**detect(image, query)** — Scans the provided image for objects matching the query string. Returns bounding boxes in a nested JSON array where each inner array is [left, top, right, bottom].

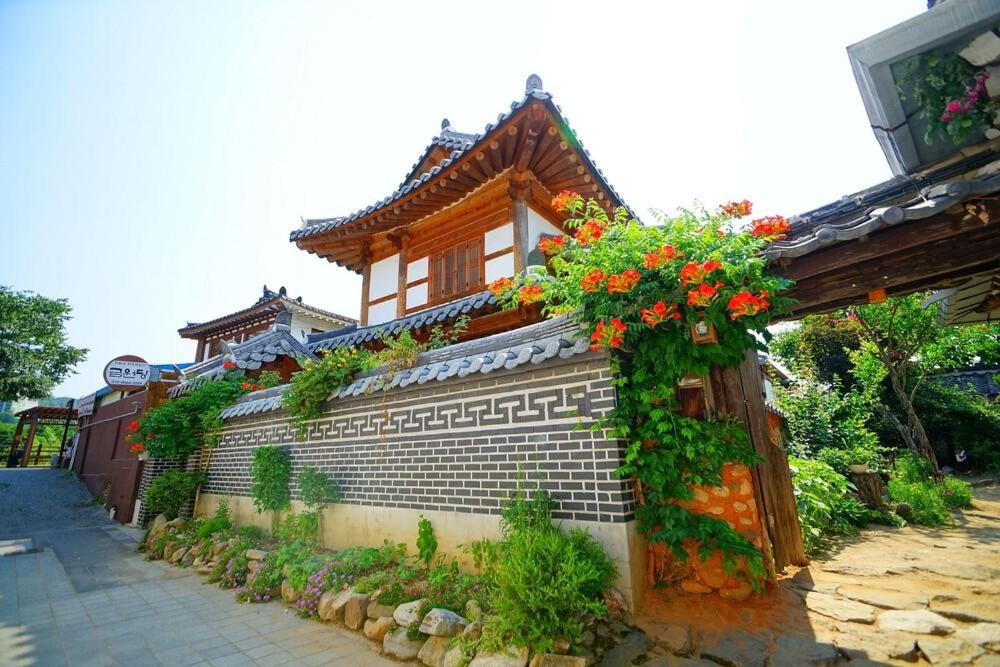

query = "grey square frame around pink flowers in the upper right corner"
[[847, 0, 1000, 175]]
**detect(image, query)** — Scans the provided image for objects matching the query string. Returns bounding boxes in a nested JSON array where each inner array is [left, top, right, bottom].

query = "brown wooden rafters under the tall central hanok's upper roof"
[[293, 95, 622, 273]]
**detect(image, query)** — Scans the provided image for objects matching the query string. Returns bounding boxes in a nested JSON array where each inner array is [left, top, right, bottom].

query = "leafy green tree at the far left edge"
[[0, 285, 87, 401]]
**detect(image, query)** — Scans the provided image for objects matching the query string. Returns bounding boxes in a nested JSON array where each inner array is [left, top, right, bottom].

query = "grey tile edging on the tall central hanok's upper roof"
[[289, 75, 628, 241]]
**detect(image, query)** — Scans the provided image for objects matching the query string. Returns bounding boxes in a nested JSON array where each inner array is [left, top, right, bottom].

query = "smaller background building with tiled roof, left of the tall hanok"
[[177, 285, 357, 362]]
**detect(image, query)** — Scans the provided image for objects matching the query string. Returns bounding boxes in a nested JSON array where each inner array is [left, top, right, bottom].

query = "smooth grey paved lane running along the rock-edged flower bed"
[[0, 469, 393, 667]]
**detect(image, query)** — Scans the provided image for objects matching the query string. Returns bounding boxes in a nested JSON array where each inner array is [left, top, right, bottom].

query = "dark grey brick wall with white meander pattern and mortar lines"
[[204, 354, 635, 523]]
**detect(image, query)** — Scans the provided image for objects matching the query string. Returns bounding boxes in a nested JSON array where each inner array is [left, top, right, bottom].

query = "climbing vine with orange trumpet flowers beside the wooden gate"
[[490, 192, 790, 585]]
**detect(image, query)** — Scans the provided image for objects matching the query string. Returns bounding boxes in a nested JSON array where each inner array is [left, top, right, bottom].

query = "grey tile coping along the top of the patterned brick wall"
[[222, 316, 589, 419]]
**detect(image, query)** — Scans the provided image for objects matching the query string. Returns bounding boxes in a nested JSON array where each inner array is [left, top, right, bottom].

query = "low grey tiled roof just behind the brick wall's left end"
[[168, 324, 316, 398]]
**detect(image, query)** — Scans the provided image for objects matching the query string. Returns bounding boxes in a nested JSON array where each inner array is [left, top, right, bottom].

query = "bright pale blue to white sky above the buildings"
[[0, 0, 925, 396]]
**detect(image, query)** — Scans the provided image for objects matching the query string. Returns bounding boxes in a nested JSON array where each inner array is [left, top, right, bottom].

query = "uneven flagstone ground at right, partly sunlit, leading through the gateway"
[[636, 482, 1000, 666]]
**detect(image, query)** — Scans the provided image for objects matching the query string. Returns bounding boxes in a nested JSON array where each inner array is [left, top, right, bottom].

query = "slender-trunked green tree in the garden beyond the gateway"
[[848, 294, 1000, 472]]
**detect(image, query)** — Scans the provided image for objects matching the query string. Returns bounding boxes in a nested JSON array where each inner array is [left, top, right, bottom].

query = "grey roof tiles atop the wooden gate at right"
[[764, 150, 1000, 261]]
